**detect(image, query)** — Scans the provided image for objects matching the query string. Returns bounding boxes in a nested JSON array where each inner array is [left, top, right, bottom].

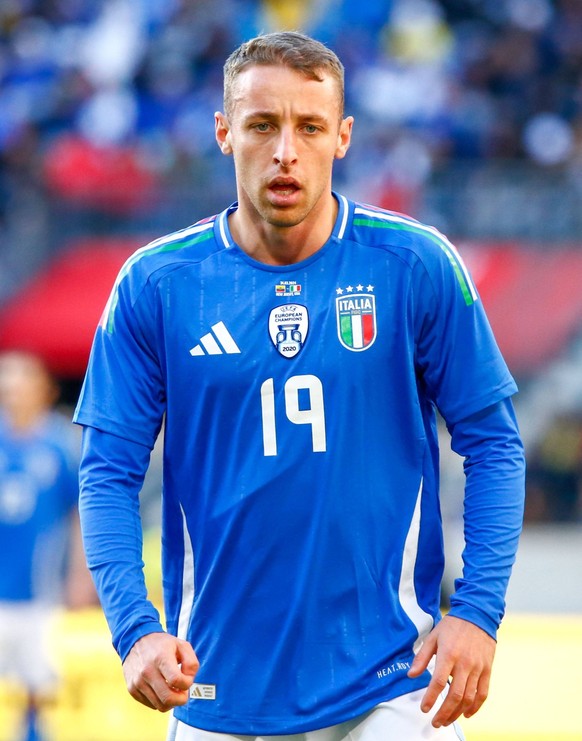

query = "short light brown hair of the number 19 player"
[[224, 31, 344, 118]]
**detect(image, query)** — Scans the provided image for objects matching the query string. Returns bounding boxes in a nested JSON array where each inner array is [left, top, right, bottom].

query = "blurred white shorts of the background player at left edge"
[[0, 602, 57, 694]]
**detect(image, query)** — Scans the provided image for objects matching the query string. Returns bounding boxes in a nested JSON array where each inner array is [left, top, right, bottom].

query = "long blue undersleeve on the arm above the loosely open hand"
[[449, 399, 525, 638]]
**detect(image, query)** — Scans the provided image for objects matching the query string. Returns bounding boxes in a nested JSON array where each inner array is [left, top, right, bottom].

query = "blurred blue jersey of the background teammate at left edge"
[[0, 413, 78, 602]]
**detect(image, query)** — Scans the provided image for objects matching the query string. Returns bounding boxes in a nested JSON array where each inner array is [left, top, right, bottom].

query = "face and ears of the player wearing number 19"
[[216, 65, 353, 227]]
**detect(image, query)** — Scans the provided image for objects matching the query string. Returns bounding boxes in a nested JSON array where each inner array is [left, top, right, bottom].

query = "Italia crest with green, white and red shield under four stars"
[[335, 286, 377, 352]]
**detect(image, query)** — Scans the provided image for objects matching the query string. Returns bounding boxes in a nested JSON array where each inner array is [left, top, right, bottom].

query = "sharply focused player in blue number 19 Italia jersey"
[[75, 32, 524, 741]]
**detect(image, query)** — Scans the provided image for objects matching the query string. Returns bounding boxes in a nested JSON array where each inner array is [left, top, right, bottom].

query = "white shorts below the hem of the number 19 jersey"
[[167, 689, 465, 741]]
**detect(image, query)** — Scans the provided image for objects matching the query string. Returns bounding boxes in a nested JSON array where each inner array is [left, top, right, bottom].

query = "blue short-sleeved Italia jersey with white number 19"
[[76, 195, 516, 734]]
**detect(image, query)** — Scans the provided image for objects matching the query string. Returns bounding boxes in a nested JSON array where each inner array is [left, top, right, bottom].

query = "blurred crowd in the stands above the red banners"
[[0, 0, 582, 284]]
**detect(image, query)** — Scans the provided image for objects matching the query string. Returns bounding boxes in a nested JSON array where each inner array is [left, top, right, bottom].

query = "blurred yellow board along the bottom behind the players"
[[0, 608, 582, 741]]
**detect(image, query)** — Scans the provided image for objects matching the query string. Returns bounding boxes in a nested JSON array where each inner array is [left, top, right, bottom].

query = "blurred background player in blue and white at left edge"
[[0, 351, 89, 741]]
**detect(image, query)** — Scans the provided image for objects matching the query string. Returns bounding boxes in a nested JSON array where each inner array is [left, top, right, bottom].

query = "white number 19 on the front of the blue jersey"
[[261, 375, 326, 456]]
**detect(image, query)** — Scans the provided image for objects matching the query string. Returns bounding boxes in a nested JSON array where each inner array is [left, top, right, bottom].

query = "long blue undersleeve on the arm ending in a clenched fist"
[[79, 427, 163, 661]]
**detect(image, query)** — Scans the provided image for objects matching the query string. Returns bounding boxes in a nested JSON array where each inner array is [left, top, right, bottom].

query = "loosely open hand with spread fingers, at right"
[[408, 615, 497, 728]]
